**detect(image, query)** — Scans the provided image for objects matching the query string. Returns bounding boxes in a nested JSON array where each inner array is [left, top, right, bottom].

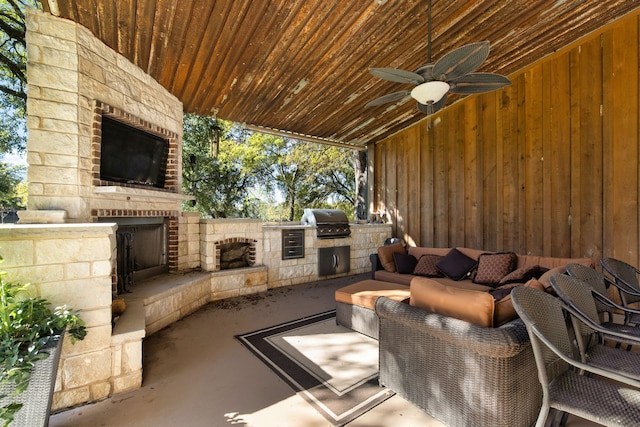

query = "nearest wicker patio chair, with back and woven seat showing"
[[511, 286, 640, 427]]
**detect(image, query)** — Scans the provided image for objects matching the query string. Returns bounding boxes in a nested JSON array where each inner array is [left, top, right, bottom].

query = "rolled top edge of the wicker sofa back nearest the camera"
[[376, 297, 530, 358]]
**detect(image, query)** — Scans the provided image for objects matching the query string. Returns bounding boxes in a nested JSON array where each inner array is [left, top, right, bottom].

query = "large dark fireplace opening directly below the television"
[[101, 217, 169, 294]]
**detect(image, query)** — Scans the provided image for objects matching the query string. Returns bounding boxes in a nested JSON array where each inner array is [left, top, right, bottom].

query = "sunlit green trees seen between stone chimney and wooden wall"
[[182, 114, 356, 221]]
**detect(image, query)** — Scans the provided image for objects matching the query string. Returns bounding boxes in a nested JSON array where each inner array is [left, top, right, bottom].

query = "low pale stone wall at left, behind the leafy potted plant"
[[0, 224, 144, 410]]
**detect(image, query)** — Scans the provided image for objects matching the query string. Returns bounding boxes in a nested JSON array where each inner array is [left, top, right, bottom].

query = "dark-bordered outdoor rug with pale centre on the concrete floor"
[[236, 310, 394, 426]]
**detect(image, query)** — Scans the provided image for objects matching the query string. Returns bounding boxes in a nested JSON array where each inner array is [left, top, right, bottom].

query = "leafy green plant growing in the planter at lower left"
[[0, 272, 86, 426]]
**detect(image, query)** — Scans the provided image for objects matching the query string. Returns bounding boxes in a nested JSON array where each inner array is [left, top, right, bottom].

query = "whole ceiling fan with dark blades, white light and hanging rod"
[[365, 0, 511, 114]]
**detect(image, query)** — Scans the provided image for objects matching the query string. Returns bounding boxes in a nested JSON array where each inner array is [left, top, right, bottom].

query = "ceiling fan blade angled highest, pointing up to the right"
[[433, 41, 489, 82]]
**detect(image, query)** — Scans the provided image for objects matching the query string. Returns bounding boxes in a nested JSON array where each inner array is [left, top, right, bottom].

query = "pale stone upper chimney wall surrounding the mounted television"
[[27, 9, 184, 222]]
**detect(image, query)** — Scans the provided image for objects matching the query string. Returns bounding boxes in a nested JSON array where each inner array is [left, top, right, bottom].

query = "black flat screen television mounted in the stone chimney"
[[100, 116, 169, 188]]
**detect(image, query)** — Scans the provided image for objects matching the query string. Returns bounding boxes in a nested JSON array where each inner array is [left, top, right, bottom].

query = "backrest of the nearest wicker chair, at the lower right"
[[511, 286, 574, 390]]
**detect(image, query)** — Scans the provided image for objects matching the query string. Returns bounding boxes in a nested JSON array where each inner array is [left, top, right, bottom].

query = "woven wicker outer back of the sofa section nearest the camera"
[[376, 297, 542, 427]]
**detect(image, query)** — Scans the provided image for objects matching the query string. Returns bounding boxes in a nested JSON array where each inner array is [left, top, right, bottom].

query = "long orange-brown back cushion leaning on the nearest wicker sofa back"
[[409, 277, 494, 327]]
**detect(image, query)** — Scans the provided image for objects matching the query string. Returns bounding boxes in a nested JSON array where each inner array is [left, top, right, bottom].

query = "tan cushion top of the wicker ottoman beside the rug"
[[335, 280, 409, 310]]
